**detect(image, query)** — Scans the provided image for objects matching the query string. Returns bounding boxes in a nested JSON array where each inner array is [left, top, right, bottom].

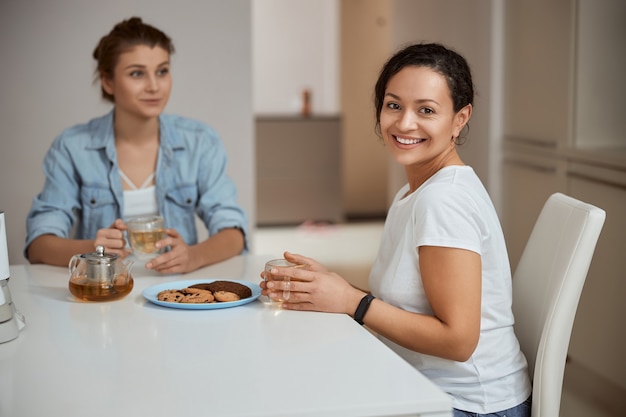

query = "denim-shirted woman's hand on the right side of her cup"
[[146, 229, 197, 274]]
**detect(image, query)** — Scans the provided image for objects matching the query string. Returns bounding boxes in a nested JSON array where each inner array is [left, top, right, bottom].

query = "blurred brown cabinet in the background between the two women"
[[255, 116, 343, 226]]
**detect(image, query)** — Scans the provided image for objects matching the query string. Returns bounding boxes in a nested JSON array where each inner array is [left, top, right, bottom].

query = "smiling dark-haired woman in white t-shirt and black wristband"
[[261, 44, 531, 417]]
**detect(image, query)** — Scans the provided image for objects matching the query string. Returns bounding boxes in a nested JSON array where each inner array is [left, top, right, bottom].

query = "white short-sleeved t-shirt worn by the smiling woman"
[[369, 166, 531, 414]]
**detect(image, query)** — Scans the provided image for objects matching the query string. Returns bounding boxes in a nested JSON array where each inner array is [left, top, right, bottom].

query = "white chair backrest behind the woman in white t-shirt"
[[513, 193, 606, 417]]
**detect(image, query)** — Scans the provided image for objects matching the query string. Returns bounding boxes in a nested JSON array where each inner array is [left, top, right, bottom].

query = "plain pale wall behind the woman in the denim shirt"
[[0, 0, 255, 264]]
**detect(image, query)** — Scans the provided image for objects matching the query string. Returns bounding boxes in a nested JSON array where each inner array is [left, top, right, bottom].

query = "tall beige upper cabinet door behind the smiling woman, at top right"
[[504, 0, 575, 147]]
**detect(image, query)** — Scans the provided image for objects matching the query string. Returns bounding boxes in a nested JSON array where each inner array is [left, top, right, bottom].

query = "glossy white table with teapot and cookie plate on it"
[[0, 255, 451, 417]]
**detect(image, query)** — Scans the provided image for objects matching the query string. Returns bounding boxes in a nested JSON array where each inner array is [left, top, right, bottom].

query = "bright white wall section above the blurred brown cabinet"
[[252, 0, 339, 115]]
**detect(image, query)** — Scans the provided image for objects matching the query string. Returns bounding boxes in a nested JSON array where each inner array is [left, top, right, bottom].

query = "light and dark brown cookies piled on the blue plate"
[[157, 281, 252, 304]]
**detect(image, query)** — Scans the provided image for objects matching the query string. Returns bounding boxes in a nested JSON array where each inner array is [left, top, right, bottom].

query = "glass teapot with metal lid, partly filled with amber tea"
[[68, 246, 134, 301]]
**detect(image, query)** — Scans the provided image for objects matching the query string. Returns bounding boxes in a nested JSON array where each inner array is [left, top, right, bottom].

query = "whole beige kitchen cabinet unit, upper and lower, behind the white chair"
[[501, 0, 626, 394]]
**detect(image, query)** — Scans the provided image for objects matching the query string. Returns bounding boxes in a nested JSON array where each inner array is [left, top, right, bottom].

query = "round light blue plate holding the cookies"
[[141, 279, 261, 310]]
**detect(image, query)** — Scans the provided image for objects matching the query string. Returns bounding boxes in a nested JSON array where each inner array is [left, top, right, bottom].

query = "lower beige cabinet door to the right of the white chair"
[[567, 173, 626, 388]]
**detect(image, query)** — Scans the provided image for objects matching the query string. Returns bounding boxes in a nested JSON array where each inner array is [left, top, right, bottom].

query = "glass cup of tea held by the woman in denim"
[[126, 216, 167, 259]]
